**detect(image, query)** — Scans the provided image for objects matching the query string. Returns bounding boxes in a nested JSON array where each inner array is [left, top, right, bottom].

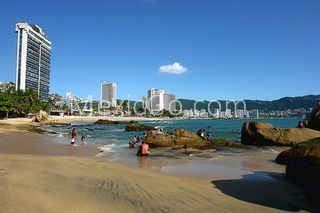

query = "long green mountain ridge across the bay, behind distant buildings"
[[177, 95, 320, 112]]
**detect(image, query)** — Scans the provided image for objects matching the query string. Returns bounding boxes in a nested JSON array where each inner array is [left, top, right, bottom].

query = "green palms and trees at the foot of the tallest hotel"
[[0, 87, 53, 118]]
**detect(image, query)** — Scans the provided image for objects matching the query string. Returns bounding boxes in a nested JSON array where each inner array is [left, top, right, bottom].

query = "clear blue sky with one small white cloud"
[[0, 0, 320, 100]]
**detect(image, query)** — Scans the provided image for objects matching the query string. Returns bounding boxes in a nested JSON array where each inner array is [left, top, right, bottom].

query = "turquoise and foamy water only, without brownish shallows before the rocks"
[[48, 118, 299, 152]]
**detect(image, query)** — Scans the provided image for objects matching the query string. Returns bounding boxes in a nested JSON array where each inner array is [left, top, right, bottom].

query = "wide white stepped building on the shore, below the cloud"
[[144, 88, 176, 112]]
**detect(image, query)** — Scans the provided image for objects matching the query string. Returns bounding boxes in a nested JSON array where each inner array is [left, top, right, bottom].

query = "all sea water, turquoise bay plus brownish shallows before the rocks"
[[47, 118, 299, 176]]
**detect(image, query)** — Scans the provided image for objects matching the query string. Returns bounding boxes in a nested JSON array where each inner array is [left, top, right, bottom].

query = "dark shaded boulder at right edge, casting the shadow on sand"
[[276, 138, 320, 203]]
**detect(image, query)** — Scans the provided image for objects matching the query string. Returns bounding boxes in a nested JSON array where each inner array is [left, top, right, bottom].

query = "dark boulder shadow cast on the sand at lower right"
[[211, 171, 319, 212]]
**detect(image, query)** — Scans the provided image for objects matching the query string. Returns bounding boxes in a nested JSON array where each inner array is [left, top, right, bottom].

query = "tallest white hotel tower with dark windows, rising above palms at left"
[[15, 23, 51, 100]]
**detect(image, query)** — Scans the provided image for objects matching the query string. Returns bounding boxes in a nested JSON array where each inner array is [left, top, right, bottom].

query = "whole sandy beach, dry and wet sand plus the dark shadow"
[[0, 118, 317, 212]]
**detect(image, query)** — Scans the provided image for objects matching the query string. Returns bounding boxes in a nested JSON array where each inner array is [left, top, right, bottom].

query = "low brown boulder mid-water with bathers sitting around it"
[[145, 129, 207, 148]]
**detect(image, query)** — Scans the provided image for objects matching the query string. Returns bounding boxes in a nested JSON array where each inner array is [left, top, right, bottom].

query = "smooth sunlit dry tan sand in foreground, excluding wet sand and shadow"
[[0, 154, 304, 212]]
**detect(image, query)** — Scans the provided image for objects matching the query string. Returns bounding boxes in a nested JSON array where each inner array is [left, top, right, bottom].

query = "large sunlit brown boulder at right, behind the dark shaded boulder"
[[241, 122, 320, 146]]
